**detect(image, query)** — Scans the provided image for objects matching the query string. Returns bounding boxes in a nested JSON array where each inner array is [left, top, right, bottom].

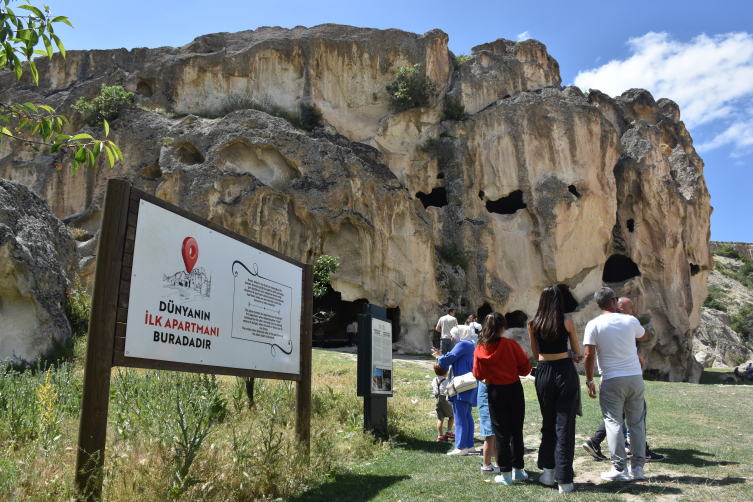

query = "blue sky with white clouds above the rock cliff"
[[34, 0, 753, 242]]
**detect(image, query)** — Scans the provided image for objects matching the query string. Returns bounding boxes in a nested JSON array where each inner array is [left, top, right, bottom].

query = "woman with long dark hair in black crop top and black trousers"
[[528, 286, 583, 493]]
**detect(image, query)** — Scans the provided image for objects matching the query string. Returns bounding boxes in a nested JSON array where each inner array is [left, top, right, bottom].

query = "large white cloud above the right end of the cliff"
[[575, 32, 753, 150]]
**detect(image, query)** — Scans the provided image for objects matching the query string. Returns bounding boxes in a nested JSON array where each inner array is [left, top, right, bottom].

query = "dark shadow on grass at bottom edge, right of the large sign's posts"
[[288, 474, 410, 502]]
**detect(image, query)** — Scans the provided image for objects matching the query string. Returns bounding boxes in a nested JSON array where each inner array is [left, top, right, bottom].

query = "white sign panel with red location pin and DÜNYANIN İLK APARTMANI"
[[125, 200, 303, 375]]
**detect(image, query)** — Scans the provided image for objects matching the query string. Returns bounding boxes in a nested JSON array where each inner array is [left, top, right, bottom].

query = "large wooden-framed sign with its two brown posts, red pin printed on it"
[[75, 179, 314, 500]]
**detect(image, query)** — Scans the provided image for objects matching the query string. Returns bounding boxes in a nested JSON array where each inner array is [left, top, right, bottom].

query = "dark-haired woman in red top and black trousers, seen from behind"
[[473, 312, 531, 485]]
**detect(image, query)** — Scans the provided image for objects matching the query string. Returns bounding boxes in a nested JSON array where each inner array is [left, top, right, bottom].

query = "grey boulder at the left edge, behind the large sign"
[[0, 179, 76, 363]]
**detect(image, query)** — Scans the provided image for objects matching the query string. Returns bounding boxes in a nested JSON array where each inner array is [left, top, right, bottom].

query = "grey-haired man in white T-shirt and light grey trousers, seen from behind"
[[583, 288, 648, 481]]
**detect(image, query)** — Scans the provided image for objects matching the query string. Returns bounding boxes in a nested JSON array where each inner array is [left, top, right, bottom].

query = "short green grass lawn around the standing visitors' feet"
[[294, 351, 753, 502]]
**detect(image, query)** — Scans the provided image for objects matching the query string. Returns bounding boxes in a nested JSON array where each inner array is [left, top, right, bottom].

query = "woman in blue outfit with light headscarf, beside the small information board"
[[431, 330, 477, 455]]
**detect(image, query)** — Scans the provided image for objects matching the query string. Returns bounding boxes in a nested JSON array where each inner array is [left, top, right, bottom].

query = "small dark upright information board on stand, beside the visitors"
[[357, 303, 394, 434]]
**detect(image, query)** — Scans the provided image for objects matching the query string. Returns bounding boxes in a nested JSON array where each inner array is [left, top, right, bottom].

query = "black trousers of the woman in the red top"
[[486, 380, 526, 472]]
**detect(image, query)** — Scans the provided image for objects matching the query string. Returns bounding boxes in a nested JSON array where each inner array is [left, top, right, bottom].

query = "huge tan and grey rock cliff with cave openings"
[[0, 25, 713, 381]]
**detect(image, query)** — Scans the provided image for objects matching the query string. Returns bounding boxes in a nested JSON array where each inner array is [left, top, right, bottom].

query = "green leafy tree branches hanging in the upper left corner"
[[0, 0, 123, 174]]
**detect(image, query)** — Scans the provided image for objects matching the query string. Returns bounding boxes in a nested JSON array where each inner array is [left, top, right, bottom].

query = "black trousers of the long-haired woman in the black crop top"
[[536, 358, 580, 484]]
